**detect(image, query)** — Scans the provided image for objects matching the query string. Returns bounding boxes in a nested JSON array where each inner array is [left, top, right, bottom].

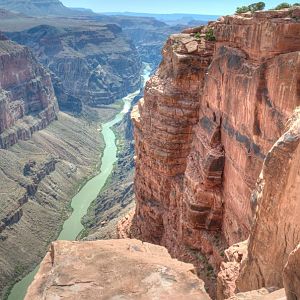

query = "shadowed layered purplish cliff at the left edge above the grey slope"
[[0, 35, 58, 148]]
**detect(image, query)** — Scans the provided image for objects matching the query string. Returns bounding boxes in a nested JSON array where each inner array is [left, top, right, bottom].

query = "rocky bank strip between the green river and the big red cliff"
[[80, 64, 152, 240]]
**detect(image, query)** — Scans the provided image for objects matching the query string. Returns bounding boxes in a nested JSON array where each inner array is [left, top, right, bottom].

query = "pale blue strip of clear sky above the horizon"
[[61, 0, 298, 15]]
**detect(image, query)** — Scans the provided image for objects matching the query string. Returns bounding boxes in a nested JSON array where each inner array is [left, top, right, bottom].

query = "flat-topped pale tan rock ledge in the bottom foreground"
[[25, 240, 210, 300]]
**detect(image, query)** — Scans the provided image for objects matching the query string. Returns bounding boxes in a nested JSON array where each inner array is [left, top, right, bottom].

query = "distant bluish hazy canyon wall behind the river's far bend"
[[8, 23, 142, 110]]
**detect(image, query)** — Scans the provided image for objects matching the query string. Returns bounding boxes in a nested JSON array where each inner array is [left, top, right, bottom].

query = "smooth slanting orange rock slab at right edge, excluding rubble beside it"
[[237, 108, 300, 296]]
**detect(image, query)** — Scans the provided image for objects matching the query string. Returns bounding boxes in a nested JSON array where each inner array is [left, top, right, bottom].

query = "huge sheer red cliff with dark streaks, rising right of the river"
[[133, 9, 300, 265]]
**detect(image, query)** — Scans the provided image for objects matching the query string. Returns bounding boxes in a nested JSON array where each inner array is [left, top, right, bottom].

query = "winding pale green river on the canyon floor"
[[8, 63, 151, 300]]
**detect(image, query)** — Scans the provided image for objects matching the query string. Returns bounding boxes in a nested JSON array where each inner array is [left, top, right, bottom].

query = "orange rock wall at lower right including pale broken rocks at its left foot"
[[218, 107, 300, 299]]
